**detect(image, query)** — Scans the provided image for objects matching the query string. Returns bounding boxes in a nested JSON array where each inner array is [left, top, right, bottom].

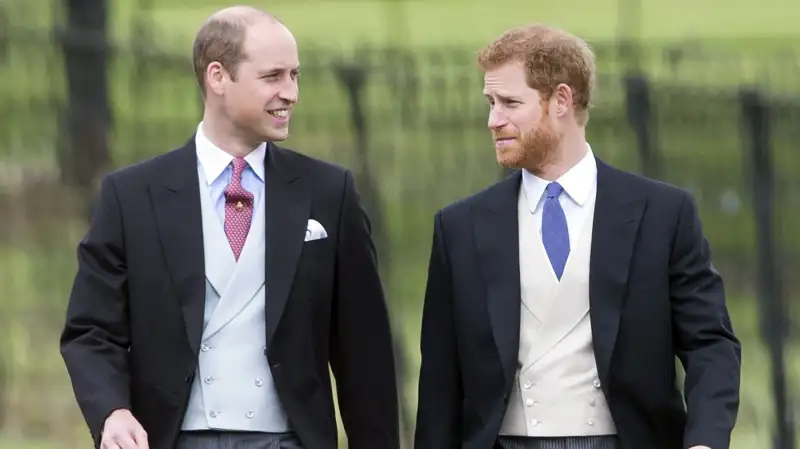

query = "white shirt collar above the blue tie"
[[522, 143, 597, 212]]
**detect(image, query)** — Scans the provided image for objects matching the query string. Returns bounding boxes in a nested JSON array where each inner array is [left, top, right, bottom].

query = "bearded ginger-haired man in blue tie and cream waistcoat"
[[415, 25, 740, 449]]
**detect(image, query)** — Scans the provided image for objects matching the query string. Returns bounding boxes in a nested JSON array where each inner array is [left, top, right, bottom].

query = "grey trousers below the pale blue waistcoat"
[[175, 431, 303, 449]]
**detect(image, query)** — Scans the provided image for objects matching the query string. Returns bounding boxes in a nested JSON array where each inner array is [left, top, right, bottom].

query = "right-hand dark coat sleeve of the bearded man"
[[670, 194, 741, 449]]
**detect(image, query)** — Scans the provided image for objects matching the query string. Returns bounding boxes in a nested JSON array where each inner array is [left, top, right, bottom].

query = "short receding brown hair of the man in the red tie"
[[192, 6, 280, 95]]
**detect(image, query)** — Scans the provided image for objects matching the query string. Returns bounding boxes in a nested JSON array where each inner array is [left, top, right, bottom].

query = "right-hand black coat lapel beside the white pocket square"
[[264, 144, 311, 347]]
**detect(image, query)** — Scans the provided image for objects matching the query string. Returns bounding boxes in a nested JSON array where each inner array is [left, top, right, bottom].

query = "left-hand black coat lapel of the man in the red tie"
[[149, 136, 206, 354]]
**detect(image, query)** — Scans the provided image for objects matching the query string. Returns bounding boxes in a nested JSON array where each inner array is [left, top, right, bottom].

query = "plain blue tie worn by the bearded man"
[[542, 182, 569, 280]]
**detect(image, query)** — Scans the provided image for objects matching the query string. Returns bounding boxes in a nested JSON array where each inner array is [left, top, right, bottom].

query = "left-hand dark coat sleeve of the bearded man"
[[414, 212, 463, 449]]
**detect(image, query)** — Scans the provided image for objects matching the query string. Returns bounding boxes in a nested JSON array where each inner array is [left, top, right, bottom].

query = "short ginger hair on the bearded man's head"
[[477, 23, 595, 125]]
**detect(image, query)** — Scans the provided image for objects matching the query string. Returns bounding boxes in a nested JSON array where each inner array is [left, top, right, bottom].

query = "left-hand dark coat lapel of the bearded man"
[[473, 172, 522, 386]]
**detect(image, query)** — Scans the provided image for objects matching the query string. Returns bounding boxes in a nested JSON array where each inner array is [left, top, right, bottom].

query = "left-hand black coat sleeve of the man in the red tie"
[[60, 173, 130, 446]]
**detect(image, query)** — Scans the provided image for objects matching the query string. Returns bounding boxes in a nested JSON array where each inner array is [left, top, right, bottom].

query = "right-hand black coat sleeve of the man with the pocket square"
[[330, 171, 400, 449]]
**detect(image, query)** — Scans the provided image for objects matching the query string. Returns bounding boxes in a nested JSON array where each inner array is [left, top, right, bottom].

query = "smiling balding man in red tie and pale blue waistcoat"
[[61, 6, 399, 449]]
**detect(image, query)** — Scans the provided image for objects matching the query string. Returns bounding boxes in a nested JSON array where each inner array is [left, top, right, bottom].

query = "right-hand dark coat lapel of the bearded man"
[[589, 159, 646, 393]]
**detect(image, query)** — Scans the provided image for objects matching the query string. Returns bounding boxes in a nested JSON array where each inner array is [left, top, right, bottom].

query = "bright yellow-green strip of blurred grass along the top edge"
[[125, 0, 800, 48]]
